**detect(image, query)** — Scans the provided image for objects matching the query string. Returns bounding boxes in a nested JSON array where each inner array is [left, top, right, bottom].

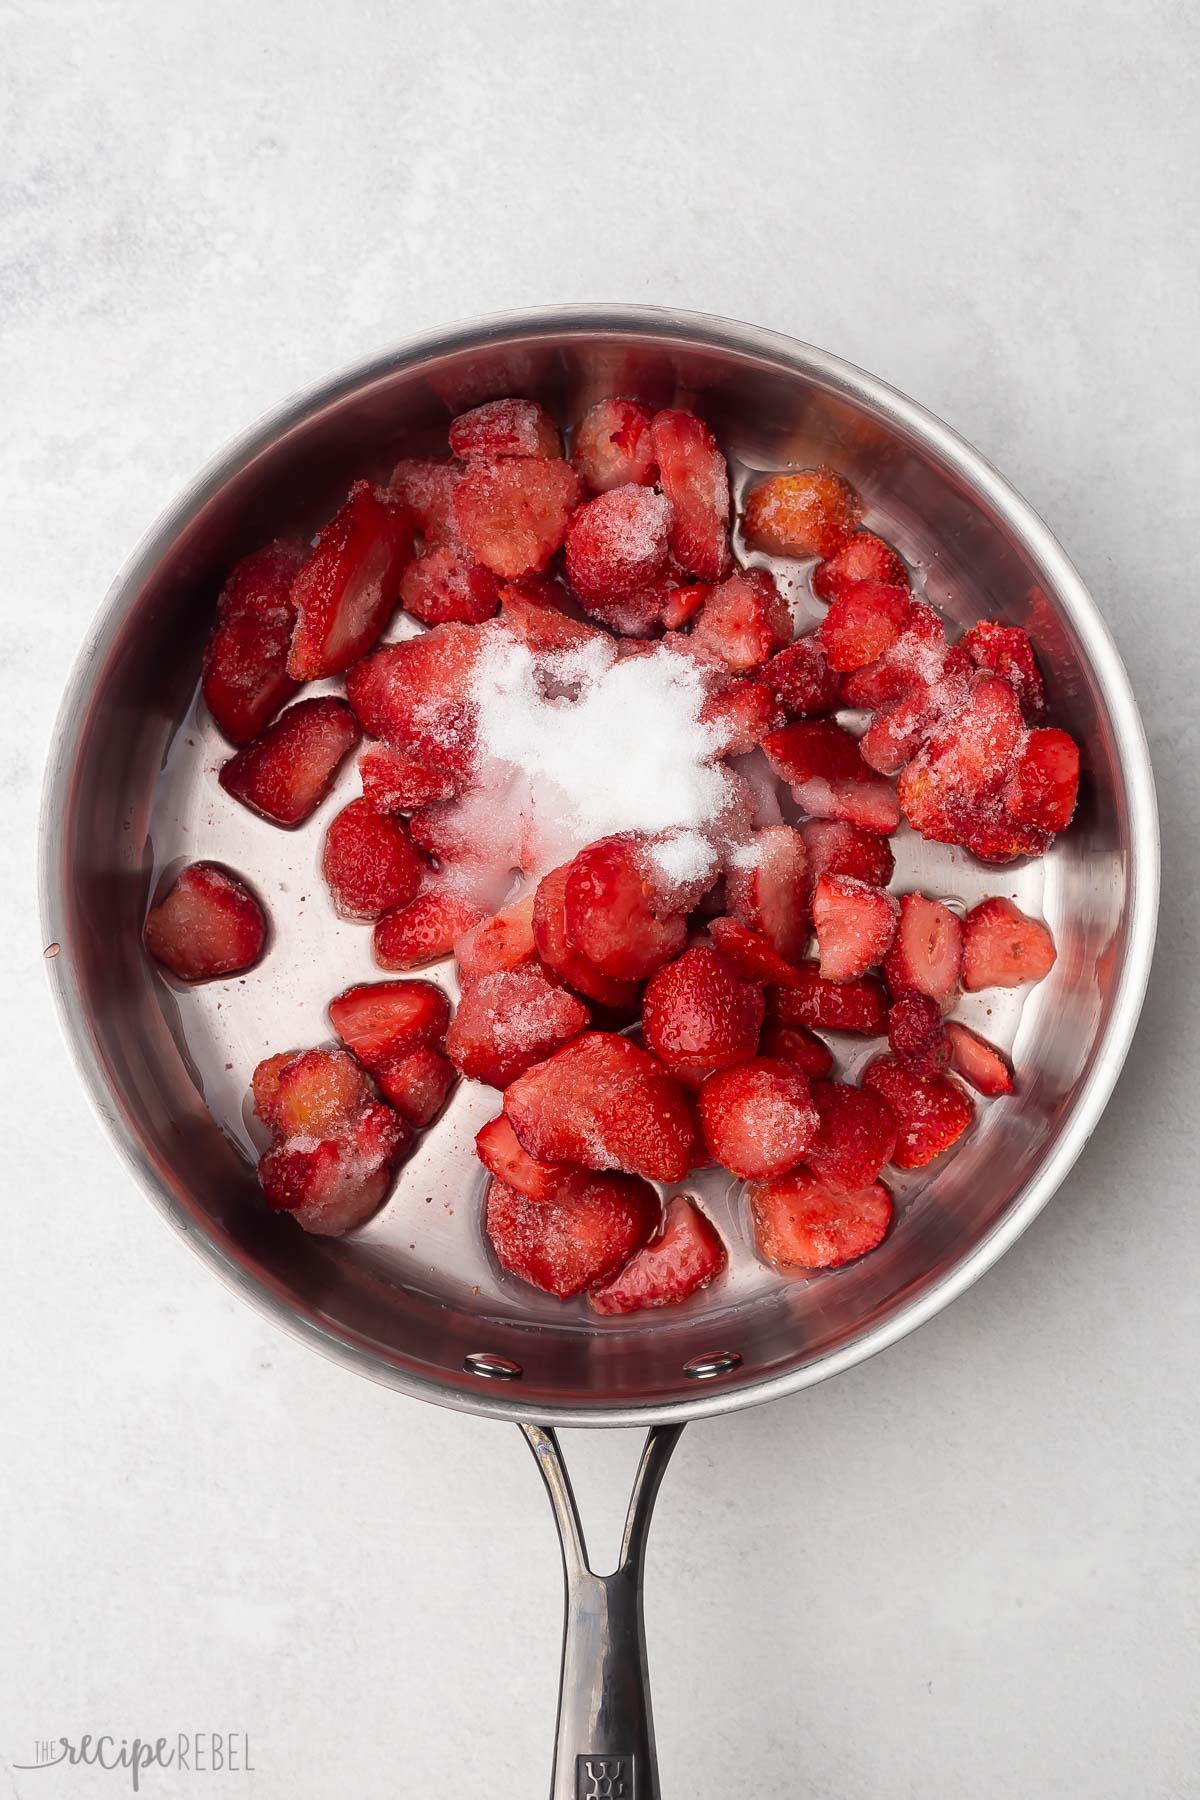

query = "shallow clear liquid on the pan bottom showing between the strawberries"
[[149, 470, 1060, 1332]]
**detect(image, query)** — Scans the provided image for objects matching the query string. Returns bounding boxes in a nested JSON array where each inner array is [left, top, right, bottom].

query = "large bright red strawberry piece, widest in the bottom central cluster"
[[504, 1036, 694, 1181]]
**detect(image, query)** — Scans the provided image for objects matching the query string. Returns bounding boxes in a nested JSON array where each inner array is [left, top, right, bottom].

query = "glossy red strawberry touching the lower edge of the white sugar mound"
[[565, 837, 687, 981]]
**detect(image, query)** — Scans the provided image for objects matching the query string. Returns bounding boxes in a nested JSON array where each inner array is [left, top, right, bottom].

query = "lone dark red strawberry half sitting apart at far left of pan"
[[144, 862, 266, 981]]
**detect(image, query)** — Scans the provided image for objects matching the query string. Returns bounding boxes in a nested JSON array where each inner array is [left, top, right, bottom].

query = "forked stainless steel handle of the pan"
[[522, 1426, 684, 1800]]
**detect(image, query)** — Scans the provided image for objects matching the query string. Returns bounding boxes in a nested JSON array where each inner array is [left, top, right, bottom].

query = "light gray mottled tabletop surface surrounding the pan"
[[0, 0, 1200, 1800]]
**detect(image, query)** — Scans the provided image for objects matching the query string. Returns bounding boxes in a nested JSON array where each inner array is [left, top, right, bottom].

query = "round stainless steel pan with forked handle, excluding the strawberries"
[[41, 308, 1159, 1800]]
